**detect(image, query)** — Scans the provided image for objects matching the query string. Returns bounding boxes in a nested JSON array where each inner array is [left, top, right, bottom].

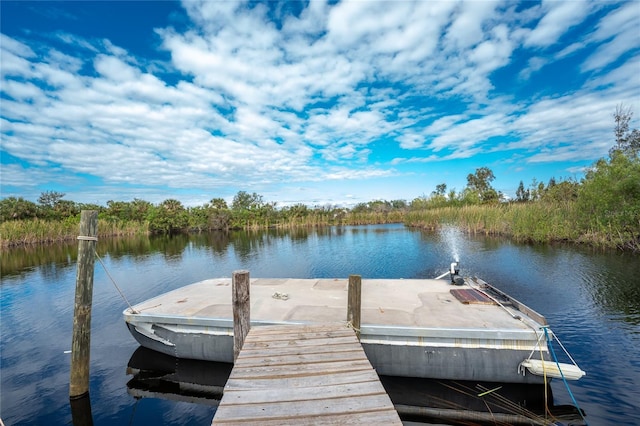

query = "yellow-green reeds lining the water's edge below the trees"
[[0, 203, 640, 252]]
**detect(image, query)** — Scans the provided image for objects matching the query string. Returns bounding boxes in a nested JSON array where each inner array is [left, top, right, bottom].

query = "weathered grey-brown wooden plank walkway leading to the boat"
[[213, 323, 402, 425]]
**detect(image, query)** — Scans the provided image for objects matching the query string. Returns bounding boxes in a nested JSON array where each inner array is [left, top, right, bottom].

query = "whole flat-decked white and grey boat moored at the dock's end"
[[124, 278, 564, 383]]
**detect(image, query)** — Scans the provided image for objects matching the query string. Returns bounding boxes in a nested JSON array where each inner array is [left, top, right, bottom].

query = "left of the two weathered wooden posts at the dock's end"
[[231, 270, 251, 363]]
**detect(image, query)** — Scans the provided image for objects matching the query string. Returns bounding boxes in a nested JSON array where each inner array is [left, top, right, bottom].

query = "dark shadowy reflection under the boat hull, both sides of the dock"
[[125, 347, 580, 426]]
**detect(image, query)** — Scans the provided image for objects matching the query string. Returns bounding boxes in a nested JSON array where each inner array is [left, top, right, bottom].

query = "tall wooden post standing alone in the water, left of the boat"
[[69, 210, 98, 398]]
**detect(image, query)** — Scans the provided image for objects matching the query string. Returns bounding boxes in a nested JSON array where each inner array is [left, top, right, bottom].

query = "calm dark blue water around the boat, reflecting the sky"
[[0, 225, 640, 426]]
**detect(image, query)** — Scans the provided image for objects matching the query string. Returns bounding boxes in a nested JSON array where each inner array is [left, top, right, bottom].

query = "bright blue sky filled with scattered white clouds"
[[0, 0, 640, 206]]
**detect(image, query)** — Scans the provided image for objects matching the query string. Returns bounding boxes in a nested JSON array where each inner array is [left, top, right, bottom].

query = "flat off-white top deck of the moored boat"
[[125, 278, 540, 334]]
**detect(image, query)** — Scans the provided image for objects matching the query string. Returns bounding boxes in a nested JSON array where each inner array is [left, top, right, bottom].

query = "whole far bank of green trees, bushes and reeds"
[[0, 105, 640, 252]]
